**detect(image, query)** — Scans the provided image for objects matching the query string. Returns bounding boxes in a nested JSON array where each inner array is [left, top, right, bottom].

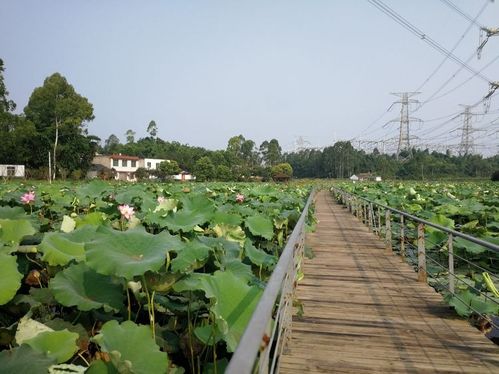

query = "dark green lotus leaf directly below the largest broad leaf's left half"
[[49, 263, 123, 311]]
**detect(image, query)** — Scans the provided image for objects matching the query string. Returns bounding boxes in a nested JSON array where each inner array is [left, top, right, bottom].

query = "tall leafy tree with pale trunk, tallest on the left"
[[24, 73, 94, 179]]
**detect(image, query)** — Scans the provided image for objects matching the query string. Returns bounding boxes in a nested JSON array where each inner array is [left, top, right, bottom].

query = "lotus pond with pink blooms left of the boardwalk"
[[0, 181, 310, 374]]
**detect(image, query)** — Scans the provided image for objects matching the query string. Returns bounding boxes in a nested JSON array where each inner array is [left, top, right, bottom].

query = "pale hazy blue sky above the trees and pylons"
[[0, 0, 499, 153]]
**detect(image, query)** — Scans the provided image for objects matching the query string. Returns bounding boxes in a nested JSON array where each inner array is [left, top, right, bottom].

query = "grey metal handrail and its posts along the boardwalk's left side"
[[225, 189, 316, 374]]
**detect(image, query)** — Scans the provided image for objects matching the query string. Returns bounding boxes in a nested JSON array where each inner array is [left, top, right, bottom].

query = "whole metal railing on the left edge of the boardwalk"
[[226, 190, 316, 374]]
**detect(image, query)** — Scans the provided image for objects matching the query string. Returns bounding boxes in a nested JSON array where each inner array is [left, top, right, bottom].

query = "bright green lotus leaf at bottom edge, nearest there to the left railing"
[[92, 320, 168, 374]]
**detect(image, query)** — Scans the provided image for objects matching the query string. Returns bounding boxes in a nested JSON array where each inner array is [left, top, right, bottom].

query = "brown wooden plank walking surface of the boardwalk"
[[280, 191, 499, 373]]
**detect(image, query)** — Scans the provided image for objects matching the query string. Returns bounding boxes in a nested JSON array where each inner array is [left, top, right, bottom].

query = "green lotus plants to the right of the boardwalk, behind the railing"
[[340, 182, 499, 316]]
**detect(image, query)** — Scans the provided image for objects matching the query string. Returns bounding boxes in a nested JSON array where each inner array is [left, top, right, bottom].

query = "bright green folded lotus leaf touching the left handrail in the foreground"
[[185, 271, 263, 352]]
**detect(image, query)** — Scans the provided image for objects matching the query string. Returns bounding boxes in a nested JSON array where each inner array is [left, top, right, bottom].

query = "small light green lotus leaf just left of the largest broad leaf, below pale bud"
[[38, 232, 85, 266]]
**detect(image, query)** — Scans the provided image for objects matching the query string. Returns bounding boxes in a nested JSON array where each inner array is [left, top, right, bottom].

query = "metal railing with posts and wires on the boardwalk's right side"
[[331, 187, 499, 328]]
